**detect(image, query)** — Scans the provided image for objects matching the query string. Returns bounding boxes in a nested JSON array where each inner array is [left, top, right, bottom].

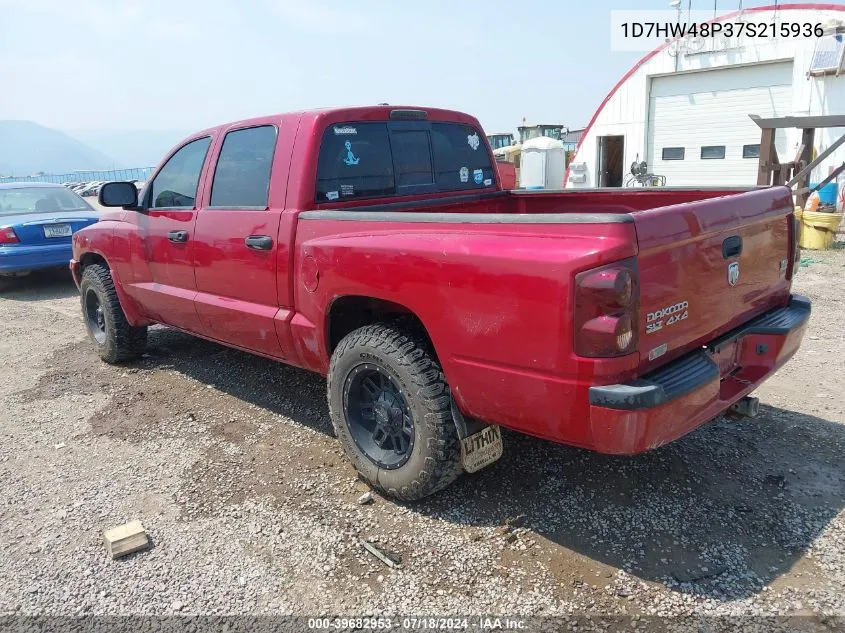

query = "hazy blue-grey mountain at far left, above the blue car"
[[0, 121, 123, 176]]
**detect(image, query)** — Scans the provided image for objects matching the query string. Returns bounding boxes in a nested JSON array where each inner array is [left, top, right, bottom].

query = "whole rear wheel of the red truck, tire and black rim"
[[328, 323, 463, 501]]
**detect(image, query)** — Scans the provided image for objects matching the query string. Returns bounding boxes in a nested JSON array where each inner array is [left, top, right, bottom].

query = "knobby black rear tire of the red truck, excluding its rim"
[[328, 323, 463, 501]]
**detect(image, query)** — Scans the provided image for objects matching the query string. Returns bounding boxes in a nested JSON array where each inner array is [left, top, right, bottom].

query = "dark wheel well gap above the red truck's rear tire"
[[326, 296, 437, 357]]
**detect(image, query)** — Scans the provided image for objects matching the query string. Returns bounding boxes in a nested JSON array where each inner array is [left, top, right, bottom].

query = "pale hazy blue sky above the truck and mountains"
[[0, 0, 784, 138]]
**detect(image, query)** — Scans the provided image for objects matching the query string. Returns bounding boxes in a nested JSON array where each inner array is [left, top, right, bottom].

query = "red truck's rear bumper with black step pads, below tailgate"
[[589, 296, 810, 455]]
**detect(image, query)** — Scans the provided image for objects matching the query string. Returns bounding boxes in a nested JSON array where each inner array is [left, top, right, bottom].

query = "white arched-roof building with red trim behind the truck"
[[565, 4, 845, 188]]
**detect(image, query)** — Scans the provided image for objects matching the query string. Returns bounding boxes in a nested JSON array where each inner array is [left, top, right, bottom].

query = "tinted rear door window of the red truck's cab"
[[211, 125, 276, 209]]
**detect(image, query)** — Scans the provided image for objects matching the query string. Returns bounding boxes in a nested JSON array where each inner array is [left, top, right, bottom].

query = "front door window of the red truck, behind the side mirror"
[[147, 136, 211, 209]]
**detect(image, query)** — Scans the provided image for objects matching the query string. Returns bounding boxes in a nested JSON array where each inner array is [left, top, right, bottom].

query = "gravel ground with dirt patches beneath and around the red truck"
[[0, 244, 845, 630]]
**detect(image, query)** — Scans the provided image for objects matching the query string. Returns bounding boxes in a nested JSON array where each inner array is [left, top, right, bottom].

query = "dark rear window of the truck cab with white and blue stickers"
[[315, 121, 496, 204]]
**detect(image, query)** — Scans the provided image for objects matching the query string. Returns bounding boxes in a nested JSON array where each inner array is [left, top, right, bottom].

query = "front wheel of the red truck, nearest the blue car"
[[79, 264, 147, 364]]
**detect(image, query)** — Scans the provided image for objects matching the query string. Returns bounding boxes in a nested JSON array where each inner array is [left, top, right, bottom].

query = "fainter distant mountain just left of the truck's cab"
[[70, 130, 191, 167]]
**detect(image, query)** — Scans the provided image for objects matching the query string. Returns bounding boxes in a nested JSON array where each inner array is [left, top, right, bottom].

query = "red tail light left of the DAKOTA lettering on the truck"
[[575, 258, 639, 358]]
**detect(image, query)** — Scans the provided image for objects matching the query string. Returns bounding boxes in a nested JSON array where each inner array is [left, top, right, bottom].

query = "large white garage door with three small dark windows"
[[648, 62, 794, 186]]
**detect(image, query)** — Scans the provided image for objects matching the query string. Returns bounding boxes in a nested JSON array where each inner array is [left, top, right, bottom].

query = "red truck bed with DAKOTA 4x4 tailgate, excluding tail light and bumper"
[[292, 188, 792, 446]]
